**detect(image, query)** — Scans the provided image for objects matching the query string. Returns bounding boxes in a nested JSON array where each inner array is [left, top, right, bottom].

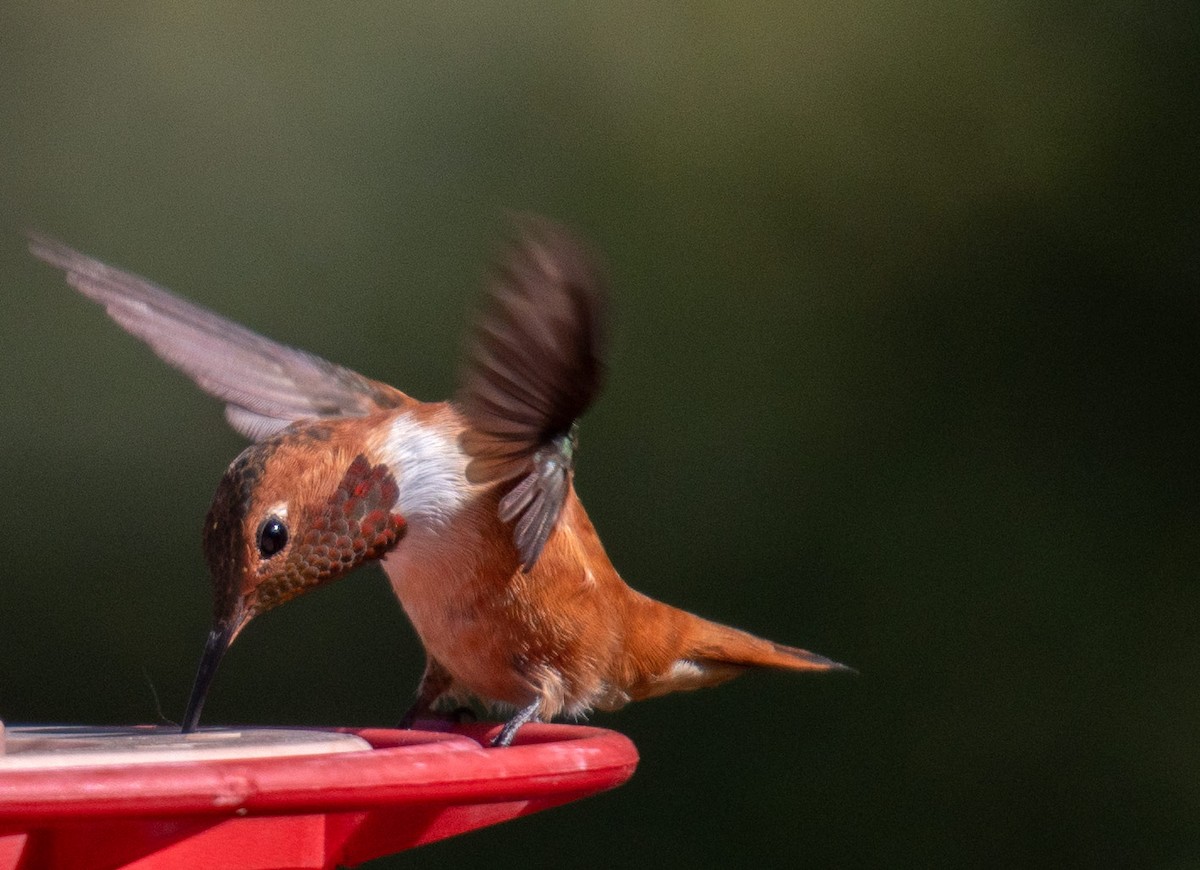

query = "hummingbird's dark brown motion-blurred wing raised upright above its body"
[[457, 217, 605, 571]]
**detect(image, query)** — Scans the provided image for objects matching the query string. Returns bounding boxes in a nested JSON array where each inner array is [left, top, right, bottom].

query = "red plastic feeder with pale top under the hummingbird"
[[0, 724, 637, 870]]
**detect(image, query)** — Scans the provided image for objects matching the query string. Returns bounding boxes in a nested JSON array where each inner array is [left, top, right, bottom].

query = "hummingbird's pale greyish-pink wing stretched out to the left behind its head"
[[29, 234, 410, 440]]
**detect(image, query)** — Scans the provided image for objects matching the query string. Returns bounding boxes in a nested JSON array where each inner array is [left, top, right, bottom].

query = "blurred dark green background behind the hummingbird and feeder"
[[0, 0, 1200, 869]]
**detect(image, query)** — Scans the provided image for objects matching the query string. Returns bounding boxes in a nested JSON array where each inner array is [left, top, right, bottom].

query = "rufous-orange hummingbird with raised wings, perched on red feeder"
[[30, 216, 852, 746]]
